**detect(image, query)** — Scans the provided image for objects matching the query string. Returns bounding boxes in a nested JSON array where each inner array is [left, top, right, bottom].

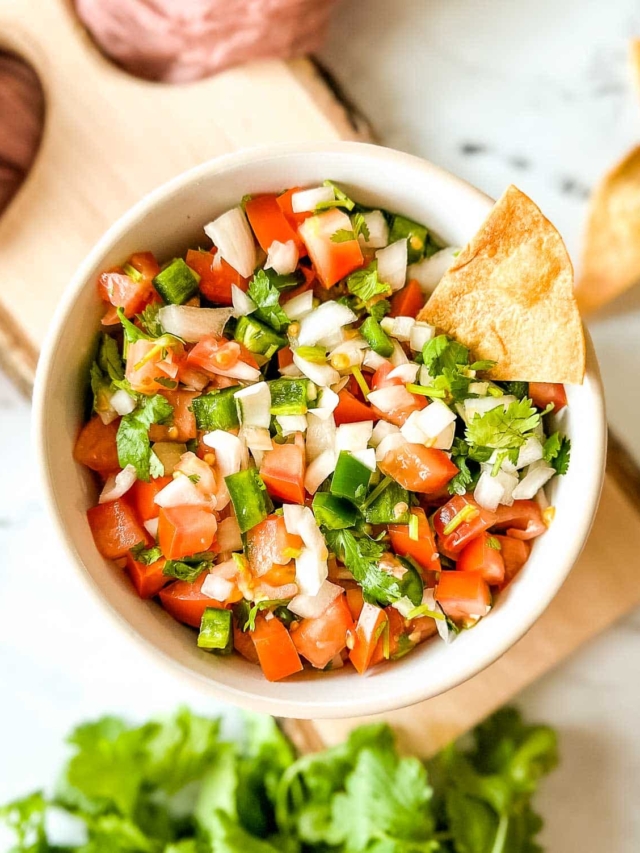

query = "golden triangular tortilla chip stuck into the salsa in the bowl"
[[418, 186, 585, 383]]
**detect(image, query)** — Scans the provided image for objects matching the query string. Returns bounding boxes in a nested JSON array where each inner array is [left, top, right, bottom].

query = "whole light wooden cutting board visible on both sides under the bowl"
[[5, 0, 640, 754]]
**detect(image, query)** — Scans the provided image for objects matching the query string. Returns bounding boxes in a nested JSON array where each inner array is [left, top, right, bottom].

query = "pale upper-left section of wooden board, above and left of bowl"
[[0, 0, 359, 385]]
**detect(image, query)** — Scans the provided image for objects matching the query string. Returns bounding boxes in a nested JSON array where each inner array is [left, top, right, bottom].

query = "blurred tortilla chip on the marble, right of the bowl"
[[576, 147, 640, 313]]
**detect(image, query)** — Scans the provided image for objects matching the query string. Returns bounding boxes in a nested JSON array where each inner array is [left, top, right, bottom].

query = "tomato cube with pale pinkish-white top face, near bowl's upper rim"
[[299, 209, 364, 288]]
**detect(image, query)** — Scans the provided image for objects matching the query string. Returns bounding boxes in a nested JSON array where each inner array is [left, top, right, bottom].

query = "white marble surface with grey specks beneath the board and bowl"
[[0, 0, 640, 853]]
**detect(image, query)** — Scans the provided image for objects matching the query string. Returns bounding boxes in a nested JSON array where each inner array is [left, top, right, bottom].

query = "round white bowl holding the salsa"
[[35, 142, 606, 718]]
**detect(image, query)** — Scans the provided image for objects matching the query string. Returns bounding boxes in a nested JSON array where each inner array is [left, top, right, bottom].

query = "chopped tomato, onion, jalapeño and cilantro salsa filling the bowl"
[[75, 181, 570, 680]]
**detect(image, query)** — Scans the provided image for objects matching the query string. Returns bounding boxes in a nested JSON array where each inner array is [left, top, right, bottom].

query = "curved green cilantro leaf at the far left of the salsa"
[[116, 394, 173, 481]]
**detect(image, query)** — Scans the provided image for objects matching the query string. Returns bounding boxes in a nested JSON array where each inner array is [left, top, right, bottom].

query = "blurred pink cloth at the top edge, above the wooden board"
[[75, 0, 335, 83]]
